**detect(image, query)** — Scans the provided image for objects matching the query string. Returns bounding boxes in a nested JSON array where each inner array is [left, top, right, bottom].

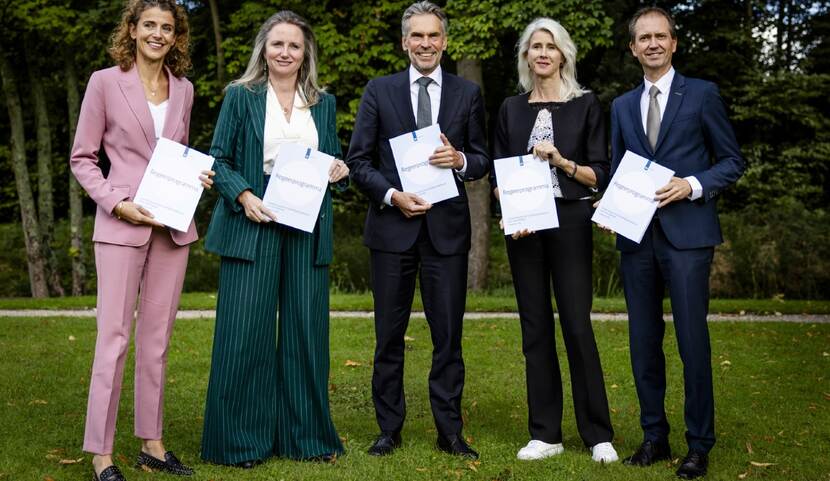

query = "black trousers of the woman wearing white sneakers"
[[506, 199, 614, 446]]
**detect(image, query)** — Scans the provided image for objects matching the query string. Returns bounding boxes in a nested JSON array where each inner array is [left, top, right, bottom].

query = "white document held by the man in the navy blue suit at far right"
[[591, 151, 674, 243]]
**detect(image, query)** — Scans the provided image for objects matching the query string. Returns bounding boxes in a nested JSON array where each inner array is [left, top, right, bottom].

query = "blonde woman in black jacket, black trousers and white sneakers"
[[491, 18, 618, 462]]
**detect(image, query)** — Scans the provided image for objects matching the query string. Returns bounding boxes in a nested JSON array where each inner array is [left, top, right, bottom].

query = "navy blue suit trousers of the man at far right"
[[620, 219, 715, 452]]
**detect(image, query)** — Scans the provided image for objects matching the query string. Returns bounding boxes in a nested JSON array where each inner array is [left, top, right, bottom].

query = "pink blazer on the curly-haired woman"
[[69, 65, 198, 246]]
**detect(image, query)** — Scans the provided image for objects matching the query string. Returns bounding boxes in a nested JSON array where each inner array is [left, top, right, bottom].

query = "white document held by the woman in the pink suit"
[[132, 137, 213, 232]]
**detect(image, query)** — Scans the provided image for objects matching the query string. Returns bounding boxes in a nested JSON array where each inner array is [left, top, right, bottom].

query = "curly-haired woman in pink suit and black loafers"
[[70, 0, 213, 481]]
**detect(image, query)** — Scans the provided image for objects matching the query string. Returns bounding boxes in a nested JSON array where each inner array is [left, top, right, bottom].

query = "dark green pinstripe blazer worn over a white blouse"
[[205, 84, 348, 265]]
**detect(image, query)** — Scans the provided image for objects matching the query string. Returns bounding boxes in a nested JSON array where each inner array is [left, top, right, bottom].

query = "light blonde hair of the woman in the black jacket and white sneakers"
[[516, 17, 587, 102]]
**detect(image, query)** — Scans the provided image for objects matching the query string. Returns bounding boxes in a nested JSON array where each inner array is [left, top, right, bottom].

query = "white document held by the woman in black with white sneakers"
[[493, 155, 559, 235]]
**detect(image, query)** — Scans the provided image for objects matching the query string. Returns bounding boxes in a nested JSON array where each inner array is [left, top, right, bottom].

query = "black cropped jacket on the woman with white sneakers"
[[490, 92, 611, 199]]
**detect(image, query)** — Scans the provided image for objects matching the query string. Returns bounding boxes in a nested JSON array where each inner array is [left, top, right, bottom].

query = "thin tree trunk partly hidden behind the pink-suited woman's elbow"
[[63, 54, 86, 296]]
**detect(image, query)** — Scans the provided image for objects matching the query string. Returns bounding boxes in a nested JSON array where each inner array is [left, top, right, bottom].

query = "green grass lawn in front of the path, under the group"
[[0, 318, 830, 481]]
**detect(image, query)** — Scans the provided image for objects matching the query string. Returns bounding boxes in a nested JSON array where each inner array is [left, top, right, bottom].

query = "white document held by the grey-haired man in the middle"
[[389, 124, 458, 204]]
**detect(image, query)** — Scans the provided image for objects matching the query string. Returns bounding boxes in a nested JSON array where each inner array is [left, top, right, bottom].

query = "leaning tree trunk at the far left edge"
[[0, 45, 49, 297]]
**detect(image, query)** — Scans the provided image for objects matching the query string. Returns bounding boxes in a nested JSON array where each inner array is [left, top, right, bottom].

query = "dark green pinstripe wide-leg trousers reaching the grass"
[[202, 224, 343, 464]]
